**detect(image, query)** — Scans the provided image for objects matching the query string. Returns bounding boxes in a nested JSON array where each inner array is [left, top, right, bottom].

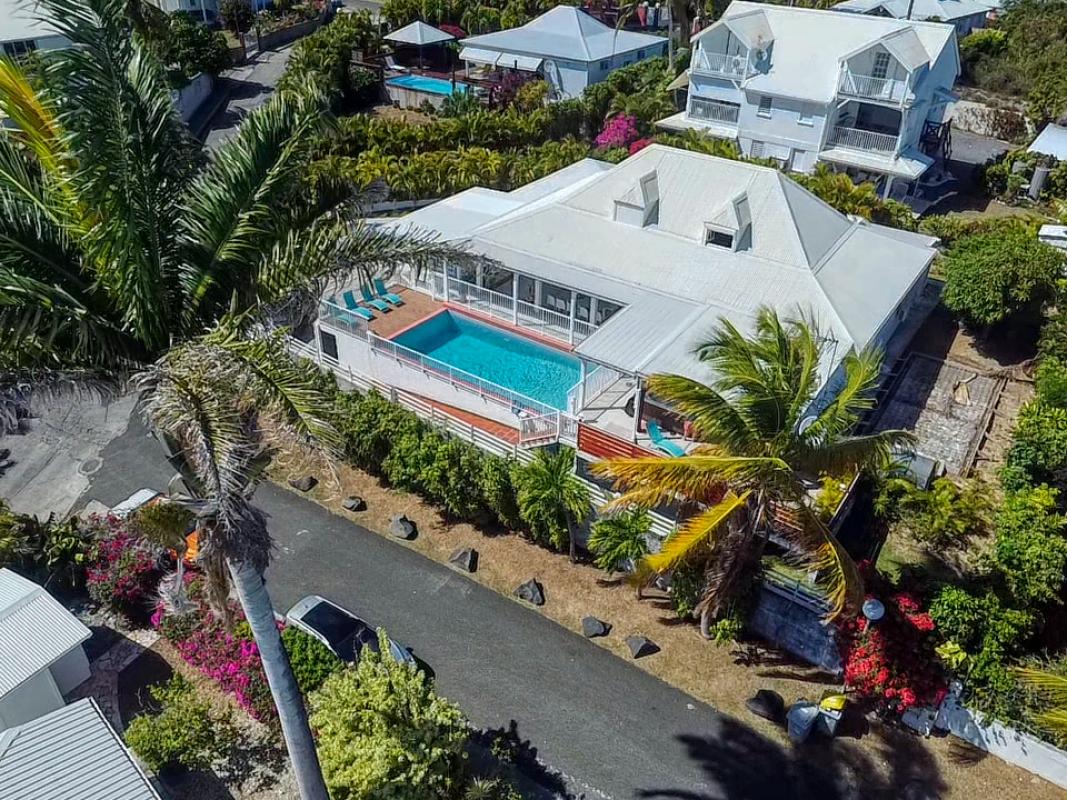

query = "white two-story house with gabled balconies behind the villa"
[[659, 0, 959, 196]]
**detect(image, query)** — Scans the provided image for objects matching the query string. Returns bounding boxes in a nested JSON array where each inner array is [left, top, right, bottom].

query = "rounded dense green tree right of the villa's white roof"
[[941, 230, 1067, 326]]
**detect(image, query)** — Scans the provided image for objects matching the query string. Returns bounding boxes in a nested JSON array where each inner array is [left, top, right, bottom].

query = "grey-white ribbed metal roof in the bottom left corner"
[[0, 698, 160, 800]]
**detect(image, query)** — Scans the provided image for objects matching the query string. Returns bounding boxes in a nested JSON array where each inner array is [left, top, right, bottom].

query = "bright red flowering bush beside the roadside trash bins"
[[839, 564, 946, 713]]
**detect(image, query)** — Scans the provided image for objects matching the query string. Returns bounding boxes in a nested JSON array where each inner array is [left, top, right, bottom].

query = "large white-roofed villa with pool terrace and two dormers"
[[298, 145, 935, 520]]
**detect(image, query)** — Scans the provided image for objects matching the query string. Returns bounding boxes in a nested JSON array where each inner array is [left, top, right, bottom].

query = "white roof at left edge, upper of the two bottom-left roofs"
[[0, 570, 90, 699]]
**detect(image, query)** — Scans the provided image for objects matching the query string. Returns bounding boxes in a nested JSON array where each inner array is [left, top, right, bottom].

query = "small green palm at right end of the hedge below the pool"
[[515, 447, 589, 561]]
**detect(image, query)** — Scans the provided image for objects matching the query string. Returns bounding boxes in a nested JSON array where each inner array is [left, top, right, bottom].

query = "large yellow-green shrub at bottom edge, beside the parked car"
[[310, 634, 469, 800]]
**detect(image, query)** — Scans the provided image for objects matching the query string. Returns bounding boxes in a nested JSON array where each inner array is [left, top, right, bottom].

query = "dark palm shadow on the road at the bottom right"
[[637, 718, 946, 800]]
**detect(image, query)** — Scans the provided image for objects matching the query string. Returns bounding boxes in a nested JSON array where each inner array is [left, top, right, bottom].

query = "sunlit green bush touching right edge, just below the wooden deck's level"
[[990, 485, 1067, 608]]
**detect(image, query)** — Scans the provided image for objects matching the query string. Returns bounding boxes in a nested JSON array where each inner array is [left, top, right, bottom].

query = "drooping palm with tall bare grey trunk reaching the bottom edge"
[[137, 317, 336, 800]]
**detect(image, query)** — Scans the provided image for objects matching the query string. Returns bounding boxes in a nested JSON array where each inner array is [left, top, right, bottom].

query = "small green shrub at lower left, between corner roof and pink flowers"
[[125, 676, 237, 771]]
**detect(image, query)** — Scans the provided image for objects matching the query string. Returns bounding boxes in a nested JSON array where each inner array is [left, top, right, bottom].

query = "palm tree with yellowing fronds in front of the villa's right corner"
[[593, 308, 910, 636]]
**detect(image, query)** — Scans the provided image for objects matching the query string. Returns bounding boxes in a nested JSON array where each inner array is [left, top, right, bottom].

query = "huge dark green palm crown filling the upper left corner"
[[0, 0, 447, 419]]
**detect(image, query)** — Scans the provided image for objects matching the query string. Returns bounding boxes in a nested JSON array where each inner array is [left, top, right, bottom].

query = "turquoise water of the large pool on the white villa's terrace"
[[393, 311, 580, 411]]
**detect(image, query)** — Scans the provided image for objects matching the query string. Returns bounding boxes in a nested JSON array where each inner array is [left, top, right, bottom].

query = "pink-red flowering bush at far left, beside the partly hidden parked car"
[[85, 514, 160, 612]]
